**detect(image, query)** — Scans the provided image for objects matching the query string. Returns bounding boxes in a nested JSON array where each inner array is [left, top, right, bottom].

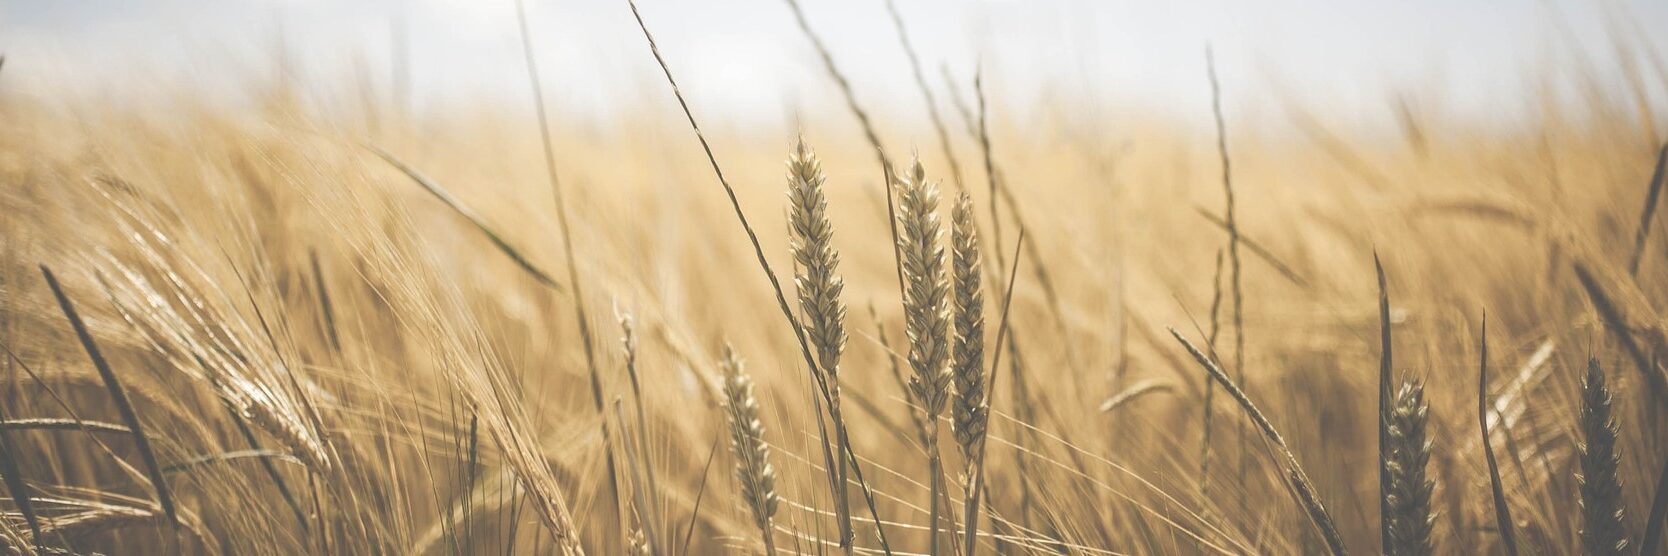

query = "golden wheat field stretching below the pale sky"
[[0, 7, 1668, 554]]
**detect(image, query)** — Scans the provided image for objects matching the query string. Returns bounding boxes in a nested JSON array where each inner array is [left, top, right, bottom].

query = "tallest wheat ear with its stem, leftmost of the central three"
[[787, 137, 852, 553]]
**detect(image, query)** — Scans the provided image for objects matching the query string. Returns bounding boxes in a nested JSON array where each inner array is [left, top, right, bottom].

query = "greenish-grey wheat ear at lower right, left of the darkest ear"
[[1381, 379, 1434, 556]]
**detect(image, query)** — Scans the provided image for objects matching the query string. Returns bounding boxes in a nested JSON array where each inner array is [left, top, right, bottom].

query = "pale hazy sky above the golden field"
[[0, 0, 1668, 131]]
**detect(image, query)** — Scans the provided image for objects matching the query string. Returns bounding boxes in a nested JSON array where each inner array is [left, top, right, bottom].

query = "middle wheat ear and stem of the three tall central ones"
[[897, 159, 951, 554]]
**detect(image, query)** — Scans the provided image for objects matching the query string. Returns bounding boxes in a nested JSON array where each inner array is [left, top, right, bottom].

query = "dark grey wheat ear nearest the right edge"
[[1576, 359, 1630, 554]]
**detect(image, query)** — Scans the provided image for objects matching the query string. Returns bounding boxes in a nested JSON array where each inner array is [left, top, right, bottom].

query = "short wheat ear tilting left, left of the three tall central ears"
[[719, 346, 779, 554]]
